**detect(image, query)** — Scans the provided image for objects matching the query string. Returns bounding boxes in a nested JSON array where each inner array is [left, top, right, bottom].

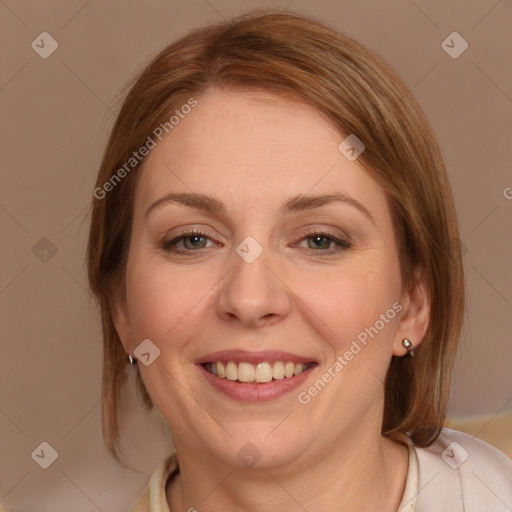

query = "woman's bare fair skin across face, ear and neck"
[[114, 89, 429, 512]]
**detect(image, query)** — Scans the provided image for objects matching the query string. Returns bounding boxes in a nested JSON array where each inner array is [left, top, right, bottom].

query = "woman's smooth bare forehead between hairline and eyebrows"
[[136, 90, 383, 215]]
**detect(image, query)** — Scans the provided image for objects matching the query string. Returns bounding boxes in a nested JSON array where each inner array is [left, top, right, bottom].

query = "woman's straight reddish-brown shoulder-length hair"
[[87, 11, 464, 457]]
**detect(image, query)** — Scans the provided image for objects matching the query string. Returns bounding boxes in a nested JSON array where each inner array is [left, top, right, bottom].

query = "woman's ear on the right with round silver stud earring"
[[393, 268, 430, 356]]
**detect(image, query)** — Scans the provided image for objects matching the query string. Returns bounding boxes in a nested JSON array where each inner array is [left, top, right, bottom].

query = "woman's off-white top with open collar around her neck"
[[130, 428, 512, 512]]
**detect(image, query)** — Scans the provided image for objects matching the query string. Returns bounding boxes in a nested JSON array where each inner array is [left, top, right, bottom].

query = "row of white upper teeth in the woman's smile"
[[205, 361, 311, 382]]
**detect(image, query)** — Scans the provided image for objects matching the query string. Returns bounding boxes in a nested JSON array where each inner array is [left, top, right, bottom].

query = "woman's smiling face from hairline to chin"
[[115, 90, 425, 467]]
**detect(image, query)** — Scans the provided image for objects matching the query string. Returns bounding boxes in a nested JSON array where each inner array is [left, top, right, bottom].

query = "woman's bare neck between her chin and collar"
[[167, 424, 408, 512]]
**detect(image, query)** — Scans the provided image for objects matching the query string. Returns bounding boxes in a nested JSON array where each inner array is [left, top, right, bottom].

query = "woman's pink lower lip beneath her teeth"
[[198, 364, 316, 402]]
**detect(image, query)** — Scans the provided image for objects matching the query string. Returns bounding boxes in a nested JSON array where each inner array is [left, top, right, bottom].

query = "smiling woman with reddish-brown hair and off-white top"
[[88, 9, 512, 512]]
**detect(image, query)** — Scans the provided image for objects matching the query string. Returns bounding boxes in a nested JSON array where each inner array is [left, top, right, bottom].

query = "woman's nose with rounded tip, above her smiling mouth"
[[217, 246, 290, 328]]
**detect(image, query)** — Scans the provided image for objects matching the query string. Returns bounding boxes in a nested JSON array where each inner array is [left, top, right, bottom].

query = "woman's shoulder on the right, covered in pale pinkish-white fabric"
[[415, 428, 512, 512]]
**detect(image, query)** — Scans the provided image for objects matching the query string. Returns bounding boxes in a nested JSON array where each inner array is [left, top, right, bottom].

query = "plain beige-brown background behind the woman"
[[0, 0, 512, 512]]
